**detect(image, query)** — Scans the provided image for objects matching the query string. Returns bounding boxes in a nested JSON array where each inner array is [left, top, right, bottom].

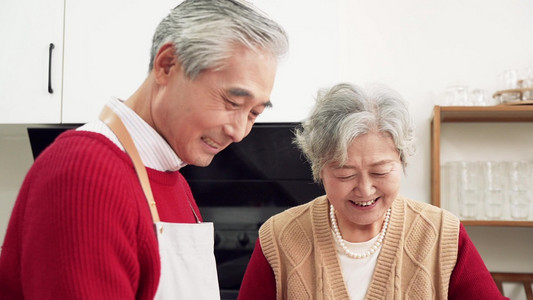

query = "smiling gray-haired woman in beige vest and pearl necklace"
[[239, 84, 507, 300]]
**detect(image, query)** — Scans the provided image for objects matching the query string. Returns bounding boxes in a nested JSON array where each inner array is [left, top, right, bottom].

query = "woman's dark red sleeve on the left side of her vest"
[[237, 239, 276, 300]]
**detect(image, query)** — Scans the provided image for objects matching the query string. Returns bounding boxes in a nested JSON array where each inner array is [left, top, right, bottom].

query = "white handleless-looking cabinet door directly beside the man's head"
[[63, 0, 179, 123]]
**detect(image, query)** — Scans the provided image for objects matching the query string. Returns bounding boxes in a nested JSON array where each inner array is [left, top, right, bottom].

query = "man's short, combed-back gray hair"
[[149, 0, 288, 79]]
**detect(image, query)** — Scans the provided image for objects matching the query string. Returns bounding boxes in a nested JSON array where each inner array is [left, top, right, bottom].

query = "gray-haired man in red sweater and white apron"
[[0, 0, 288, 299]]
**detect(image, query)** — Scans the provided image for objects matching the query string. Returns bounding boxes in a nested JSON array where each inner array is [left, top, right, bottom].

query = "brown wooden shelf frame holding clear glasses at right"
[[431, 105, 533, 227]]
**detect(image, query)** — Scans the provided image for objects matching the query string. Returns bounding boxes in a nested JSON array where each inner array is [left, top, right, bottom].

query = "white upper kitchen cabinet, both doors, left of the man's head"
[[0, 0, 180, 124]]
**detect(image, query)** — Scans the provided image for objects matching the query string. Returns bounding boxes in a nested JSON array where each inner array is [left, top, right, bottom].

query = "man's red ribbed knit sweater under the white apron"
[[0, 131, 199, 299]]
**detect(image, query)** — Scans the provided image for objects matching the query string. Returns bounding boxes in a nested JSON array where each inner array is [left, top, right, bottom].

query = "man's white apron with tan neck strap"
[[100, 107, 220, 300]]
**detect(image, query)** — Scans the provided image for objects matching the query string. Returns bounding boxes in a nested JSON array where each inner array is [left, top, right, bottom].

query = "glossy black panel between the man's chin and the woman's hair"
[[181, 123, 324, 207]]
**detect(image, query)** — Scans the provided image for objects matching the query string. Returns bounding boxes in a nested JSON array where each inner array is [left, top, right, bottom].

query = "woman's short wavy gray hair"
[[294, 83, 415, 183]]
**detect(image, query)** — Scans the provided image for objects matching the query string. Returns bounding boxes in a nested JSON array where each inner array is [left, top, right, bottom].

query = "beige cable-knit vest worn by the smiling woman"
[[259, 196, 459, 300]]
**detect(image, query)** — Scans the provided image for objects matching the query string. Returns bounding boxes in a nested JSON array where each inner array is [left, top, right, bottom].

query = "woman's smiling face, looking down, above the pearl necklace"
[[322, 132, 403, 241]]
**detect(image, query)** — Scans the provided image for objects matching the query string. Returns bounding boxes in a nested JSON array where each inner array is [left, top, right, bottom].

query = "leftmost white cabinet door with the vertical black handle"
[[0, 0, 64, 123]]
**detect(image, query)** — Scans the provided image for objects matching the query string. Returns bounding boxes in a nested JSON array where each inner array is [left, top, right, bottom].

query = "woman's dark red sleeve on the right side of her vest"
[[448, 224, 509, 300]]
